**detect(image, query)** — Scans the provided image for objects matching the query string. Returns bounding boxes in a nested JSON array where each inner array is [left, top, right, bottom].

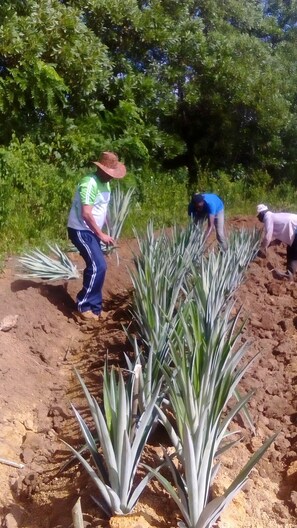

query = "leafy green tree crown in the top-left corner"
[[0, 0, 111, 144]]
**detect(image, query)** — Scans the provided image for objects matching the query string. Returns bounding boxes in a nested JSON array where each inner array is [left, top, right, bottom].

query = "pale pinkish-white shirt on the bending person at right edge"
[[262, 211, 297, 248]]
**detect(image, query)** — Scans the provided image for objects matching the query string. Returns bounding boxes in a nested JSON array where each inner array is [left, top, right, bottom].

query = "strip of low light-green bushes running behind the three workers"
[[0, 138, 297, 254]]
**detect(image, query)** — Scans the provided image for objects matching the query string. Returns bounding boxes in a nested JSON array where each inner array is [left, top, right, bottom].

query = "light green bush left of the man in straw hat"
[[0, 135, 78, 251]]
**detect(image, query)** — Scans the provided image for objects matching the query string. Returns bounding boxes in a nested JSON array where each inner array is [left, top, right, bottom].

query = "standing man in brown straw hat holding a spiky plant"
[[67, 152, 126, 321]]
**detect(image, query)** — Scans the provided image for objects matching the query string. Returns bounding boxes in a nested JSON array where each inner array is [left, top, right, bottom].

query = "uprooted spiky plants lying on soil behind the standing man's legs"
[[17, 244, 80, 281]]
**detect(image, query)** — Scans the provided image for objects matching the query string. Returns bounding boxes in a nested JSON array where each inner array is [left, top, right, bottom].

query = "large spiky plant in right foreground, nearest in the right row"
[[146, 301, 276, 528]]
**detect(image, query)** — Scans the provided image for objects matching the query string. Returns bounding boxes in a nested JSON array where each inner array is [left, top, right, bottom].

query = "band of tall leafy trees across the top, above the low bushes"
[[0, 0, 296, 185]]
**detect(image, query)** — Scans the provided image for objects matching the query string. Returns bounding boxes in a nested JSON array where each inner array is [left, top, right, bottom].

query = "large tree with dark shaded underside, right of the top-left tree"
[[76, 0, 293, 184]]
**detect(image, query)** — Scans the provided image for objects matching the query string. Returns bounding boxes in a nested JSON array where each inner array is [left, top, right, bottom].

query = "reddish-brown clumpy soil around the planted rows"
[[0, 217, 297, 528]]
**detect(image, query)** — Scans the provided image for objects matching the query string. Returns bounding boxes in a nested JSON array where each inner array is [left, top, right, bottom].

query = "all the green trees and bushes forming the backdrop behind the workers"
[[0, 0, 297, 253]]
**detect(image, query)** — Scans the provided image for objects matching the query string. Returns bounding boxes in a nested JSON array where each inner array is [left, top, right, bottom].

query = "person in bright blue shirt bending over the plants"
[[188, 193, 227, 251]]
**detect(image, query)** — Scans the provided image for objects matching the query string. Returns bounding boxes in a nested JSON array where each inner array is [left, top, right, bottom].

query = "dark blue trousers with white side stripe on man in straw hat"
[[68, 227, 106, 314]]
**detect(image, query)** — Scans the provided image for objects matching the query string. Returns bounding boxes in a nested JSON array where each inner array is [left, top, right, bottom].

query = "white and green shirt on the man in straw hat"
[[67, 174, 110, 231]]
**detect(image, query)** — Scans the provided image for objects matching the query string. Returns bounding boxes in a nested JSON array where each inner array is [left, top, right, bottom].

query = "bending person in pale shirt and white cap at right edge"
[[257, 204, 297, 279]]
